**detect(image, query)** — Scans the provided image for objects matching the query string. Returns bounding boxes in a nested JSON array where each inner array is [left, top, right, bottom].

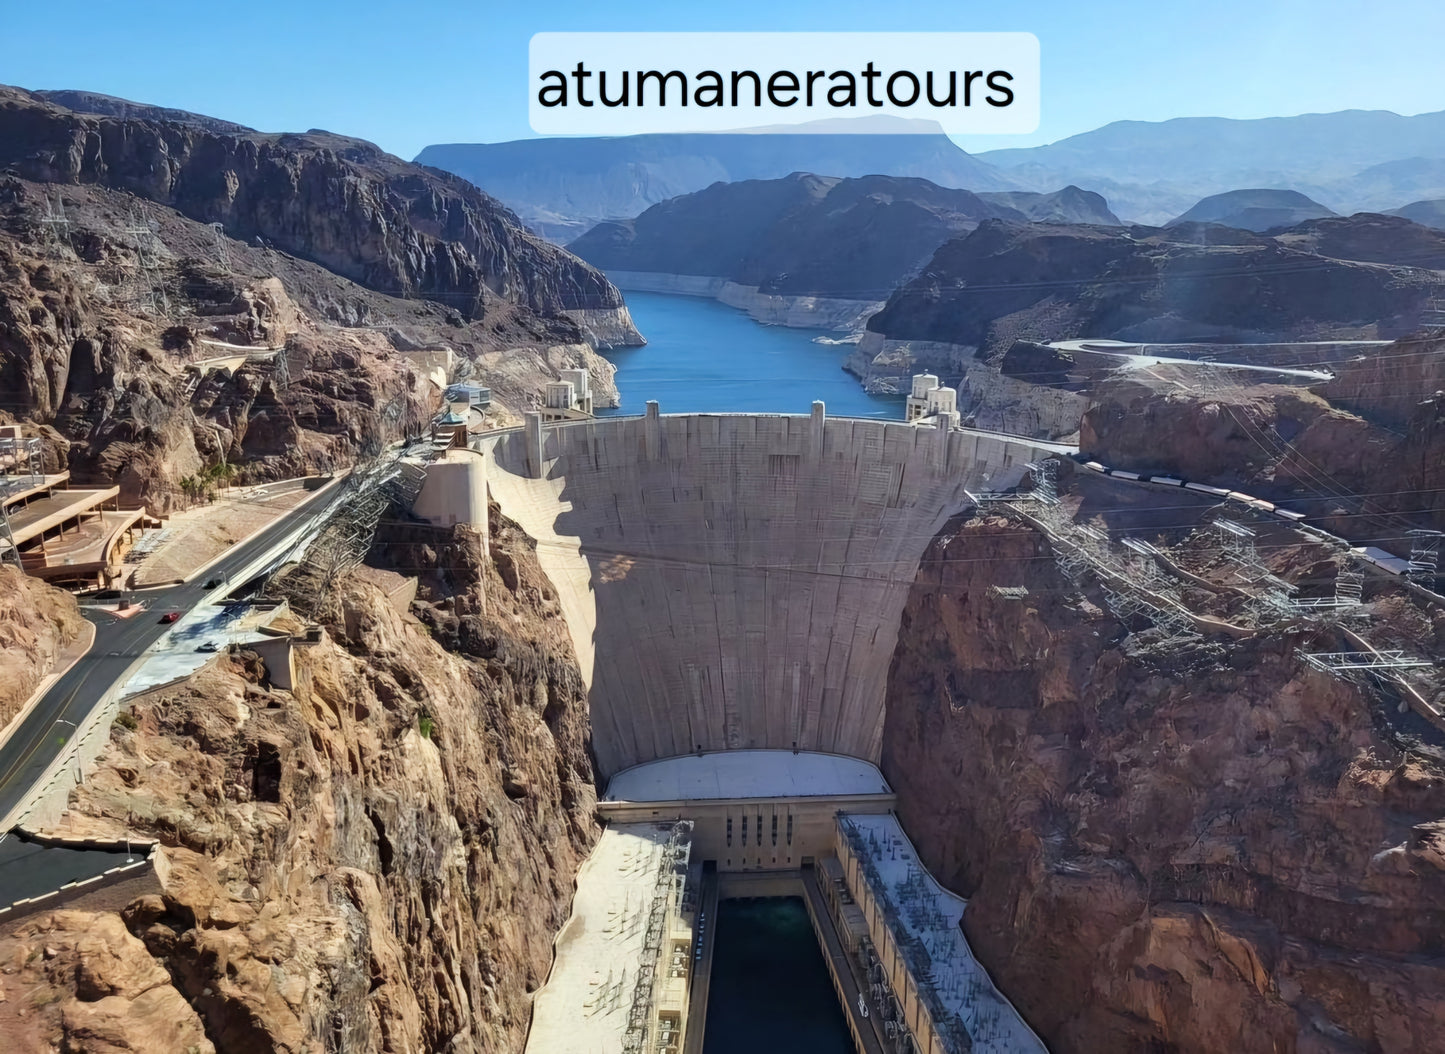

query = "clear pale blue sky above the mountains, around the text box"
[[0, 0, 1445, 158]]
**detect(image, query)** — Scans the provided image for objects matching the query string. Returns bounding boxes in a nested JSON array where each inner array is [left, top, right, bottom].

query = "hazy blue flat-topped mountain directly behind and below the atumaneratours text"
[[416, 133, 1011, 241]]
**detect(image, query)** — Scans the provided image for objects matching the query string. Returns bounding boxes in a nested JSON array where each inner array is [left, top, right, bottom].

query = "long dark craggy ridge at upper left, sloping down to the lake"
[[0, 88, 638, 332]]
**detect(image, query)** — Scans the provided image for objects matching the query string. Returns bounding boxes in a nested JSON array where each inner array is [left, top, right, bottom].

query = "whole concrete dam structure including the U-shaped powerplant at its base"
[[416, 404, 1064, 1054]]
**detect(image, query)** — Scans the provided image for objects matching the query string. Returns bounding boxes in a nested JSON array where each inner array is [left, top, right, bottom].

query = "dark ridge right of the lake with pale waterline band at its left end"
[[848, 215, 1445, 401]]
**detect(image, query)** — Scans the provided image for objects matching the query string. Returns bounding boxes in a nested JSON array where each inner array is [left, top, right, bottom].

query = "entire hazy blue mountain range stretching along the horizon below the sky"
[[416, 110, 1445, 231]]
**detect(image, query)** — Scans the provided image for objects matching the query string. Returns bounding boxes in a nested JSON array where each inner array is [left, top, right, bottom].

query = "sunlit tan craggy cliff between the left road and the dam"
[[0, 508, 597, 1051]]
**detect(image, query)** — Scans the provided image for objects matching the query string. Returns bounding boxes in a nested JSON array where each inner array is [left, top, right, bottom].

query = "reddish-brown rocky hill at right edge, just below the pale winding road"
[[1079, 335, 1445, 529]]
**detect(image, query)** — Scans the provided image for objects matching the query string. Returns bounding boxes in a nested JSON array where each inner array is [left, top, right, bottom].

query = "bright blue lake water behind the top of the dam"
[[598, 292, 903, 421]]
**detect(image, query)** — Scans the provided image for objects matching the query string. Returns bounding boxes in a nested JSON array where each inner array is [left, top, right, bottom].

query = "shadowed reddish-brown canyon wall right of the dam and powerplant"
[[881, 519, 1445, 1054]]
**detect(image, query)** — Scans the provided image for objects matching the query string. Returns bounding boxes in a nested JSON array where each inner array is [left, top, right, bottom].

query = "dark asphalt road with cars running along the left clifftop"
[[0, 486, 345, 827]]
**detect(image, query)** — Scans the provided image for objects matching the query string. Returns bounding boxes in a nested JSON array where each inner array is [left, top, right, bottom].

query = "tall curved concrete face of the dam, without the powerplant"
[[481, 403, 1049, 778]]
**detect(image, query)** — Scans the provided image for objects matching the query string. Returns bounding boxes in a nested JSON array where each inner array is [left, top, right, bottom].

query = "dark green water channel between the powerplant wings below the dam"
[[702, 896, 853, 1054]]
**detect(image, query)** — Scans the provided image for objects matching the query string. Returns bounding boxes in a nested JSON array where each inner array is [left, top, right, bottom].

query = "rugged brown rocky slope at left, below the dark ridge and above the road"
[[0, 140, 631, 512]]
